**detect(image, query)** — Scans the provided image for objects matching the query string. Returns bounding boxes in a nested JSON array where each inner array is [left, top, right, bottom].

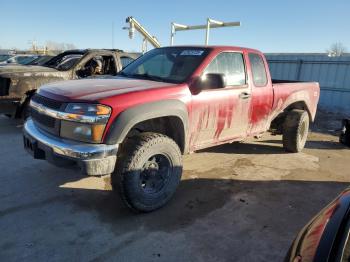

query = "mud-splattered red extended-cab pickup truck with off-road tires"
[[24, 46, 320, 212]]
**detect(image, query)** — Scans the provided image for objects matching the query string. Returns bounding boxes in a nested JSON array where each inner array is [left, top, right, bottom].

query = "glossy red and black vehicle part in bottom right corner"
[[285, 189, 350, 262]]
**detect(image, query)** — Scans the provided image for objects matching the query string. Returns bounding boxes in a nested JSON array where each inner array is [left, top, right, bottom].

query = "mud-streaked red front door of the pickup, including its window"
[[190, 52, 250, 150]]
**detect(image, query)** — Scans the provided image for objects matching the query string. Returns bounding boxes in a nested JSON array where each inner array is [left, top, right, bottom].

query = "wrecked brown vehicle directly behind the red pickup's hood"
[[0, 49, 139, 118]]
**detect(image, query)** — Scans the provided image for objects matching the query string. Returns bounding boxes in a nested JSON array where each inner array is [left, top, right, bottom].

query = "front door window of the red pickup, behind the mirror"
[[204, 52, 246, 86]]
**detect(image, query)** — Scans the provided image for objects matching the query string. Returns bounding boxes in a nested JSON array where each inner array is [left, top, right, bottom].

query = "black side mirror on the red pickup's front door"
[[192, 74, 226, 93]]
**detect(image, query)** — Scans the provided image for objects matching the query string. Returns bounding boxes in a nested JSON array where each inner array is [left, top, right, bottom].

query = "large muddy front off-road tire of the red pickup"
[[111, 133, 182, 212]]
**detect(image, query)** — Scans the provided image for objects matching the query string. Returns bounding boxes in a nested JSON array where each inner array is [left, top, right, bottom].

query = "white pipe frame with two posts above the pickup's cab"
[[170, 18, 241, 45]]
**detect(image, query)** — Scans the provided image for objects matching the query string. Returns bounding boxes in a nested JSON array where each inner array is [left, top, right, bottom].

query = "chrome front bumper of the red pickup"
[[23, 119, 118, 175]]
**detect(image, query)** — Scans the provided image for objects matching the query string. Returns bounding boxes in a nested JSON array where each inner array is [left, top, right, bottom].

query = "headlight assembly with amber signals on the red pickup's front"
[[60, 103, 111, 143]]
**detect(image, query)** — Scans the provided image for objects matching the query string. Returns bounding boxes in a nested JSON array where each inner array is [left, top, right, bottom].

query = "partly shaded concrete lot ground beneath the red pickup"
[[0, 111, 350, 261]]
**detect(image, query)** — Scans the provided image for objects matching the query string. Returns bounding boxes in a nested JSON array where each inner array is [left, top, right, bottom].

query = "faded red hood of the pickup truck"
[[38, 77, 176, 101]]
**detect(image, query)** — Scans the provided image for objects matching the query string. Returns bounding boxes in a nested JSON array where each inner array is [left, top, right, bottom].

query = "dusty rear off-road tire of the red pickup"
[[283, 109, 309, 153]]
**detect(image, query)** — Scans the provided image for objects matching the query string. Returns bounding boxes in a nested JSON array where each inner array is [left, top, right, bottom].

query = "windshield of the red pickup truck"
[[120, 47, 209, 83]]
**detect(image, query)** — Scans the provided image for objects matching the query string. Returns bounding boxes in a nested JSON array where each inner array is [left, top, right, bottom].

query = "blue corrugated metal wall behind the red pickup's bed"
[[266, 54, 350, 113]]
